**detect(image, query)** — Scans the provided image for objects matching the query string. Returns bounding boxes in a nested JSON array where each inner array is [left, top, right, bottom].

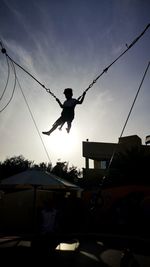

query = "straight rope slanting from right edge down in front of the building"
[[108, 61, 150, 169]]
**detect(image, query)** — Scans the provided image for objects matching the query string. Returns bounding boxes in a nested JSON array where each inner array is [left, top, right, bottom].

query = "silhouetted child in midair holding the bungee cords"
[[42, 88, 86, 135]]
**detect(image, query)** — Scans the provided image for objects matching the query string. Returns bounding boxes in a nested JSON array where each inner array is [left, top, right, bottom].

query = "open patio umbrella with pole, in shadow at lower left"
[[0, 170, 82, 233]]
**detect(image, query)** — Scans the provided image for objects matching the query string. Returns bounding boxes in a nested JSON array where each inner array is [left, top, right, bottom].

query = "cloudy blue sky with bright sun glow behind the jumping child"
[[0, 0, 150, 169]]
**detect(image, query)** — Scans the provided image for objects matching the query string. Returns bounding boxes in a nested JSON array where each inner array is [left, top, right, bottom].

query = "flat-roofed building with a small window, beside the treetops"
[[82, 135, 150, 185]]
